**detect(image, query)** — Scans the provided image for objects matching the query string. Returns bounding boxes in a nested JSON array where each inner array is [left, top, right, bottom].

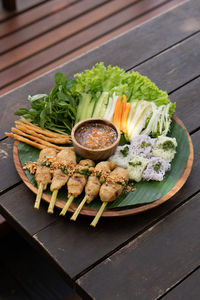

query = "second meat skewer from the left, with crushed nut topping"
[[48, 148, 76, 213]]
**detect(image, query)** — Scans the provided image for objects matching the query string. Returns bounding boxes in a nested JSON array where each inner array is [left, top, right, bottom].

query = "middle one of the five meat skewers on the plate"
[[60, 159, 94, 216]]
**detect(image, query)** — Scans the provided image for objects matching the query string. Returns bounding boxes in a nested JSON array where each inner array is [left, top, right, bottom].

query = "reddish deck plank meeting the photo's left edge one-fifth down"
[[0, 0, 148, 70]]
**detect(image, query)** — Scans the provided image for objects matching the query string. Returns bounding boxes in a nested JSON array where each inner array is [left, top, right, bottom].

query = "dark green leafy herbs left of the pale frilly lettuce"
[[15, 73, 78, 133]]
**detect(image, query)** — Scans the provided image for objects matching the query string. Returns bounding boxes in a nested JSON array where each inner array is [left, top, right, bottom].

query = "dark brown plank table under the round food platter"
[[0, 0, 200, 300]]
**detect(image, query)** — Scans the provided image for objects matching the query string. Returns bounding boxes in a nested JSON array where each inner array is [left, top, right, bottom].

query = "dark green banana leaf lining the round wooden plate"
[[18, 120, 190, 209]]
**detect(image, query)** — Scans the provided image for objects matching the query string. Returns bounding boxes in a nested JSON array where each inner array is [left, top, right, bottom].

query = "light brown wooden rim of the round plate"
[[13, 116, 194, 217]]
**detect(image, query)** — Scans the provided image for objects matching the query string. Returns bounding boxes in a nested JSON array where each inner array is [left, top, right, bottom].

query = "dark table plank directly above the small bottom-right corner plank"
[[77, 194, 200, 300]]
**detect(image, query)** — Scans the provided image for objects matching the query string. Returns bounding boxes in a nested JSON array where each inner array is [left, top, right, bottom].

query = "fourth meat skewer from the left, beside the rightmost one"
[[71, 161, 115, 221]]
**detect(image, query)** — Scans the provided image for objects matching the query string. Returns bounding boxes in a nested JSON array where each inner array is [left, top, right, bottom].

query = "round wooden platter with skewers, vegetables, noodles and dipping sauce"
[[6, 63, 193, 226]]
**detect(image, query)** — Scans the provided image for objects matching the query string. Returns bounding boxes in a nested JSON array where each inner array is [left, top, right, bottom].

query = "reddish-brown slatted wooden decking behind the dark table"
[[0, 0, 190, 94]]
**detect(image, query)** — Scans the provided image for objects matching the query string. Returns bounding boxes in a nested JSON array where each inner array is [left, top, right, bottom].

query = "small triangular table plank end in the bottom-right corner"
[[162, 268, 200, 300]]
